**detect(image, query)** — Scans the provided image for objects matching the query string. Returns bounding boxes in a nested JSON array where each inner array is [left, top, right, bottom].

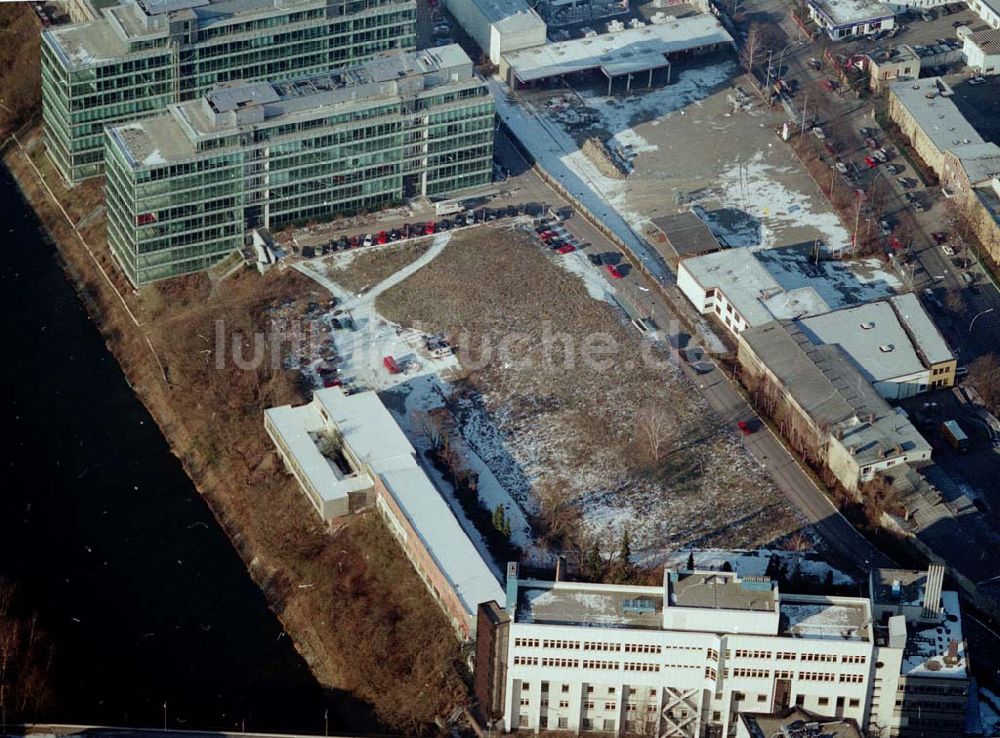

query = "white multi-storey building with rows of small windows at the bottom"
[[476, 565, 968, 738]]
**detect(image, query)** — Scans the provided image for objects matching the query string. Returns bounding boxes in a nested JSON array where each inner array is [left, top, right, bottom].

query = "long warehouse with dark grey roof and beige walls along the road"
[[738, 321, 931, 493]]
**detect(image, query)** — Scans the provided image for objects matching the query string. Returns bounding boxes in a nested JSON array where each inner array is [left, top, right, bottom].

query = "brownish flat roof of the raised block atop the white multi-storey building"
[[667, 571, 778, 612]]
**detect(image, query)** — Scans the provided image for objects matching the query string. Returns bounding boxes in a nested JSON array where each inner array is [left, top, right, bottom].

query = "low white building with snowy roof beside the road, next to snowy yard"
[[677, 248, 830, 335]]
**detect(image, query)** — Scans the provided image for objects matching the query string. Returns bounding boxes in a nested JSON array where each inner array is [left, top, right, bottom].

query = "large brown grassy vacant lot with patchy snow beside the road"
[[376, 224, 798, 561]]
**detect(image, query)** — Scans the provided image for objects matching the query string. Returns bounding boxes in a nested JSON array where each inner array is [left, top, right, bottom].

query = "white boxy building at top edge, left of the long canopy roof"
[[444, 0, 547, 64]]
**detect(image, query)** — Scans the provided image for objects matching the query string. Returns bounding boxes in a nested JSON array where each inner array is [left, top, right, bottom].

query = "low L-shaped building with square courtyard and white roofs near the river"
[[264, 387, 504, 639]]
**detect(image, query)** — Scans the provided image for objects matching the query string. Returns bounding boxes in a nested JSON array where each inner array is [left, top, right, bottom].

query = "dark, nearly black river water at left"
[[0, 169, 377, 734]]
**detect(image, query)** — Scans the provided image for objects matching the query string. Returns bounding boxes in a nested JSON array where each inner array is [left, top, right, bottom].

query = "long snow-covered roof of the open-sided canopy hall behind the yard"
[[503, 13, 733, 82]]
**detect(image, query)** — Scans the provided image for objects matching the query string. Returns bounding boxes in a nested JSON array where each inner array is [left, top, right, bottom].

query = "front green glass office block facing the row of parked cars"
[[107, 44, 493, 285]]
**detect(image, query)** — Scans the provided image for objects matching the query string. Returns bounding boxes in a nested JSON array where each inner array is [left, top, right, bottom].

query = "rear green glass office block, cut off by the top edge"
[[42, 0, 416, 183]]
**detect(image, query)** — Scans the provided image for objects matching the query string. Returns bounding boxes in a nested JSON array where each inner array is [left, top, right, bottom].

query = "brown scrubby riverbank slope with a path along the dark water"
[[4, 130, 467, 732]]
